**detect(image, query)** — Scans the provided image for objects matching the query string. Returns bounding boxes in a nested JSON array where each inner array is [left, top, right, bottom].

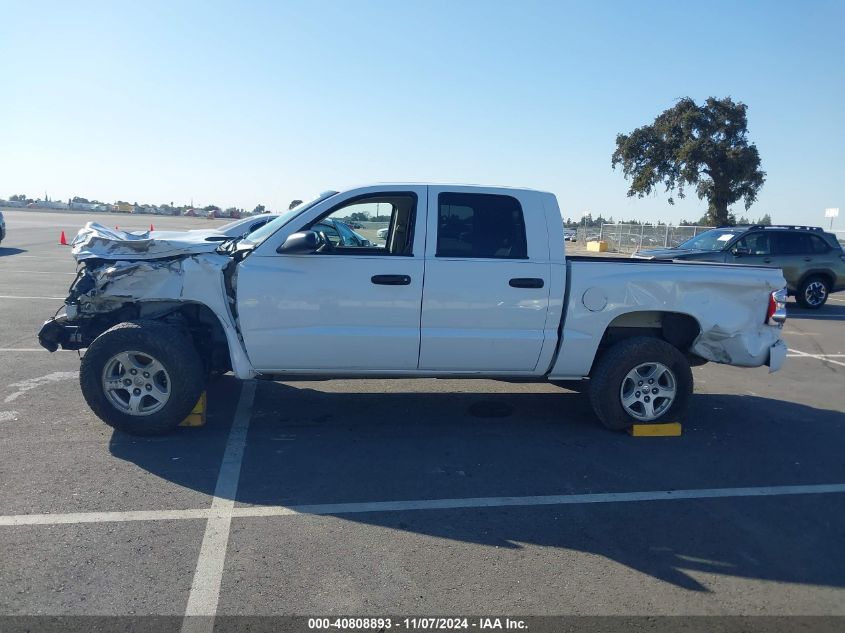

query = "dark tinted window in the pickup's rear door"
[[436, 193, 528, 259]]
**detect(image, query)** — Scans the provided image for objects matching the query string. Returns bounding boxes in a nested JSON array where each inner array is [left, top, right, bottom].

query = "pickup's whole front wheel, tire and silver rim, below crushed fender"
[[79, 321, 205, 435]]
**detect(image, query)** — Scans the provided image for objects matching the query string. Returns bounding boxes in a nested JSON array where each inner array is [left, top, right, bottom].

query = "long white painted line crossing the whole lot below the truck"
[[0, 483, 845, 524]]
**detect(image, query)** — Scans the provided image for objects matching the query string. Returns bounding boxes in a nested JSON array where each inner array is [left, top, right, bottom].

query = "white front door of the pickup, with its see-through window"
[[237, 186, 427, 373]]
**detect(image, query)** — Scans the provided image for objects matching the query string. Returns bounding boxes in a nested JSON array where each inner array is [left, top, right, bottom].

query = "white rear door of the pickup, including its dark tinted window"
[[419, 187, 562, 372]]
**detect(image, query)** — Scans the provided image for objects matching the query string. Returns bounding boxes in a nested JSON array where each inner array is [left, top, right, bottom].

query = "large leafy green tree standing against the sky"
[[612, 97, 766, 226]]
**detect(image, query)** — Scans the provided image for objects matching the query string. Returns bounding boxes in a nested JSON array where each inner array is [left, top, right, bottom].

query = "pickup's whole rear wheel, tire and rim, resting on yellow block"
[[590, 337, 693, 430]]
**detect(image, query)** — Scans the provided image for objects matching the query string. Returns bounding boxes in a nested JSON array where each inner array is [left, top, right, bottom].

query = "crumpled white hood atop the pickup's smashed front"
[[71, 222, 220, 261]]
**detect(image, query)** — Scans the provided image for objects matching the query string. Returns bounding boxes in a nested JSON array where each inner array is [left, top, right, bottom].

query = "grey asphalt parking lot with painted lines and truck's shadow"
[[0, 209, 845, 617]]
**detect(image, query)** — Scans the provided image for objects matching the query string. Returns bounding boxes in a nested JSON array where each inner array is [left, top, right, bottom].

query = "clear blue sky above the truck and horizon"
[[0, 0, 845, 228]]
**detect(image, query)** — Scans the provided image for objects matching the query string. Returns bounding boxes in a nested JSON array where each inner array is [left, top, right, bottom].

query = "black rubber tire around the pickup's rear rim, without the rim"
[[590, 336, 693, 431]]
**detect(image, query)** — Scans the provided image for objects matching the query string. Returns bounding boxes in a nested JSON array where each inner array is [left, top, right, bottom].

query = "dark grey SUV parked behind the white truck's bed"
[[632, 225, 845, 308]]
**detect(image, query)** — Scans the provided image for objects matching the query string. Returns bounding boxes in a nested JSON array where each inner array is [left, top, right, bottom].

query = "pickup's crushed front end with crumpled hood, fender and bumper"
[[38, 223, 251, 375]]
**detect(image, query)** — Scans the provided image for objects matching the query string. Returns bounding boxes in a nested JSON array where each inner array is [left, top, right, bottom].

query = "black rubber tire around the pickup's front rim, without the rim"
[[79, 321, 205, 435]]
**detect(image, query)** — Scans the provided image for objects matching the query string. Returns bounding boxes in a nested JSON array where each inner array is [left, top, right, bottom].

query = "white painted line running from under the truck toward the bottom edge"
[[182, 380, 255, 633]]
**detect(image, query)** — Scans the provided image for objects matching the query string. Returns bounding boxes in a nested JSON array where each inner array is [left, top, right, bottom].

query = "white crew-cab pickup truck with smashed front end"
[[39, 184, 786, 434]]
